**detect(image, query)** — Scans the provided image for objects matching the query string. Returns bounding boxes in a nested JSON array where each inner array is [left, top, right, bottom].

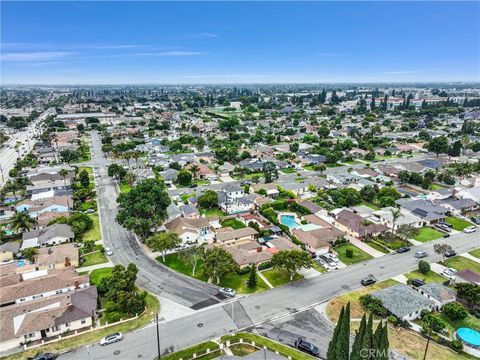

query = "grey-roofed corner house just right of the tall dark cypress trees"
[[372, 284, 436, 321]]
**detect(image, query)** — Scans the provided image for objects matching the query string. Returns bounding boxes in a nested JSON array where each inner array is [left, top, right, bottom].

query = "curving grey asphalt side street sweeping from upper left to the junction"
[[86, 131, 219, 308]]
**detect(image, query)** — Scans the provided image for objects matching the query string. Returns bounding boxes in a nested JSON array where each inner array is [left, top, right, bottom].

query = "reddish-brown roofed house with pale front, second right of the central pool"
[[334, 209, 388, 238]]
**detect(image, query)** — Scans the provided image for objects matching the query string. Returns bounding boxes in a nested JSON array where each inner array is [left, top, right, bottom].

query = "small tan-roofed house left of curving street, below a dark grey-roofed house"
[[34, 243, 79, 270]]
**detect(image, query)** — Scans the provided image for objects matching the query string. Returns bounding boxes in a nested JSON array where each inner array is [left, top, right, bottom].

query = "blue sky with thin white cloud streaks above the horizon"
[[0, 1, 480, 84]]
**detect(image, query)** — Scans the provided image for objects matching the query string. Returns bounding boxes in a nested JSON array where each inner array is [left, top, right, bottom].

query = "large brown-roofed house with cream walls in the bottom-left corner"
[[0, 286, 98, 351]]
